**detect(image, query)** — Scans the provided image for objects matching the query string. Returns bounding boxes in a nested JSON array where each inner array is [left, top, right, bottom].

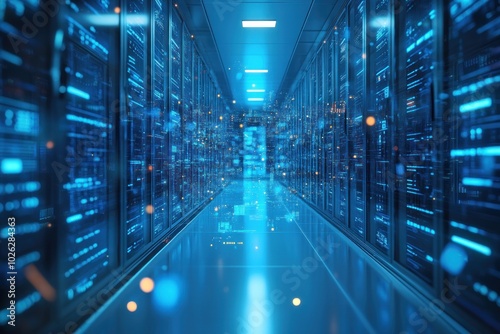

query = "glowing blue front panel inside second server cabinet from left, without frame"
[[59, 1, 114, 300]]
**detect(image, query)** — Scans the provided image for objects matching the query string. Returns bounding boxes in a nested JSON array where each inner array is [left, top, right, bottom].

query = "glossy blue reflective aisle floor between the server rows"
[[79, 180, 461, 334]]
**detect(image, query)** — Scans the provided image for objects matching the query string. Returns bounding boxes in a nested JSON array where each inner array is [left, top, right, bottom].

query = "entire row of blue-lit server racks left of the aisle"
[[0, 0, 231, 333]]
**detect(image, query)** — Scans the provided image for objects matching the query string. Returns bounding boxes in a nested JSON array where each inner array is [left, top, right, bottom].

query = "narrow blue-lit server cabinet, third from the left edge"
[[122, 0, 151, 259]]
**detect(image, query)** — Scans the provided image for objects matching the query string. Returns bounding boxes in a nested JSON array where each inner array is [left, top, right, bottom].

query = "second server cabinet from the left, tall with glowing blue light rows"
[[53, 0, 120, 308]]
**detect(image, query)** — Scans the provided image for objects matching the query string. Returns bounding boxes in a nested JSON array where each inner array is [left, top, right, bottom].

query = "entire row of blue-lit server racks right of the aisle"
[[275, 0, 500, 332]]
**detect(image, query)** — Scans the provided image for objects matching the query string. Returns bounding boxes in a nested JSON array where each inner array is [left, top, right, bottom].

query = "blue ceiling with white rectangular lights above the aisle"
[[179, 0, 337, 110]]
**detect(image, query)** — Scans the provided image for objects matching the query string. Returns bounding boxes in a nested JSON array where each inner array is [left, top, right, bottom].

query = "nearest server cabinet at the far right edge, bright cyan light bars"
[[446, 0, 500, 330]]
